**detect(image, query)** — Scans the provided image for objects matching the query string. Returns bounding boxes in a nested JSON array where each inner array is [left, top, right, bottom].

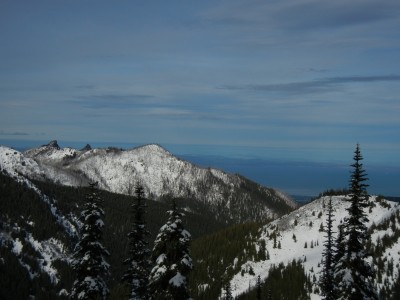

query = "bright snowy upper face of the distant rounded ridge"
[[25, 145, 244, 197]]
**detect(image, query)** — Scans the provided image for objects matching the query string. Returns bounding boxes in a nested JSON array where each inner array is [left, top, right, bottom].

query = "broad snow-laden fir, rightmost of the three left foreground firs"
[[148, 201, 193, 300]]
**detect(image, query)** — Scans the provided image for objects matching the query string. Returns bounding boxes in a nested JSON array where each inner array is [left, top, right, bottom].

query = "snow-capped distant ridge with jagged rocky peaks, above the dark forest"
[[0, 141, 297, 223]]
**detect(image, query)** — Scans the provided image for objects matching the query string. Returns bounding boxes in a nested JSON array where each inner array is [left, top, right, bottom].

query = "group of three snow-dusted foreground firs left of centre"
[[71, 184, 193, 300]]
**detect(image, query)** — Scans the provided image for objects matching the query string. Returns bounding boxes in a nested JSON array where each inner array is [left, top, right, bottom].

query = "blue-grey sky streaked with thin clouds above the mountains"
[[0, 0, 400, 167]]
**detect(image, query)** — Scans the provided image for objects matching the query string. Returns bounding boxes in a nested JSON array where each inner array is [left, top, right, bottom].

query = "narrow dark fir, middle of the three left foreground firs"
[[122, 183, 150, 300]]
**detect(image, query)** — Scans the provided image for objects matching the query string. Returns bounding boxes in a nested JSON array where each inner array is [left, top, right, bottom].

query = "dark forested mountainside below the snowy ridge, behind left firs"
[[0, 170, 231, 300]]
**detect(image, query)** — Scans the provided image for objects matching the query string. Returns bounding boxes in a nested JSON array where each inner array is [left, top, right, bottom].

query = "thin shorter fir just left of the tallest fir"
[[320, 197, 336, 300]]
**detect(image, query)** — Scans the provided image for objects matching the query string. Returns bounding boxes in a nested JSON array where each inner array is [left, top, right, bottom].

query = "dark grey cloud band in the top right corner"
[[204, 0, 400, 31]]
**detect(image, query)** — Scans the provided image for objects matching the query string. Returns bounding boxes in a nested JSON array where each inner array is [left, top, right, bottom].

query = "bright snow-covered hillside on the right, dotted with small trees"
[[227, 196, 400, 299]]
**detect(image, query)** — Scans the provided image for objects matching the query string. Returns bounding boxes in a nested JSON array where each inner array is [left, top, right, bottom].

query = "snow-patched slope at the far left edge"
[[0, 155, 77, 296]]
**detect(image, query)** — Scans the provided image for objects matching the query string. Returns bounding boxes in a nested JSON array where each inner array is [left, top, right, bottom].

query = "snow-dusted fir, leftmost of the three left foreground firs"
[[71, 183, 109, 300]]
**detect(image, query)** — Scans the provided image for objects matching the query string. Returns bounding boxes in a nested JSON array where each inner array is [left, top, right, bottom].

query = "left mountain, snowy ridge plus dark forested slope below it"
[[0, 141, 297, 299]]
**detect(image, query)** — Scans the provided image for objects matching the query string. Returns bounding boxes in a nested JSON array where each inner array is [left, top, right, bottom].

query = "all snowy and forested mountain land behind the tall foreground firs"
[[0, 141, 400, 300]]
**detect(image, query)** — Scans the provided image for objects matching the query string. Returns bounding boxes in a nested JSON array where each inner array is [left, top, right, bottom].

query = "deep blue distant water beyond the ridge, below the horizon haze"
[[181, 155, 400, 197]]
